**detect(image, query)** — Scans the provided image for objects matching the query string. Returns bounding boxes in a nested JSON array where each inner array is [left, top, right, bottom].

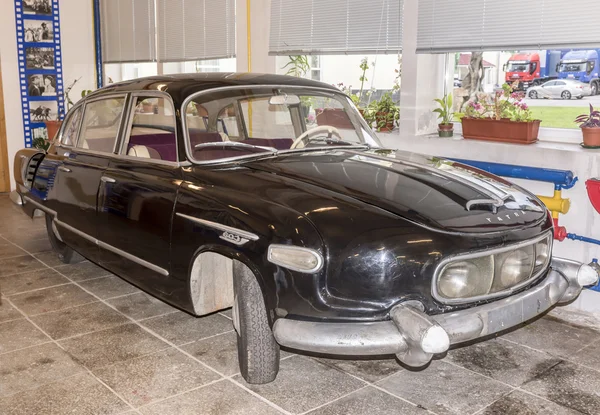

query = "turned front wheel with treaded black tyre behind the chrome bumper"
[[233, 261, 279, 384]]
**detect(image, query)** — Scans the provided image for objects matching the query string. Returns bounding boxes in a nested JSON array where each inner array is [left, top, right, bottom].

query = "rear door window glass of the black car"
[[77, 97, 125, 153]]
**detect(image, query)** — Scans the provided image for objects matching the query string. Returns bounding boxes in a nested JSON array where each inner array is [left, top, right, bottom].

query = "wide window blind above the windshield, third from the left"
[[269, 0, 404, 55]]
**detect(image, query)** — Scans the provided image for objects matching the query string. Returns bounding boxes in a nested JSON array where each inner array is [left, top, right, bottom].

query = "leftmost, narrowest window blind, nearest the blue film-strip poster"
[[100, 0, 156, 63]]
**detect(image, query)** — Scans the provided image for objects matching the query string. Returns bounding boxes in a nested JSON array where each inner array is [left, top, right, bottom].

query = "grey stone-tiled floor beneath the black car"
[[0, 195, 600, 415]]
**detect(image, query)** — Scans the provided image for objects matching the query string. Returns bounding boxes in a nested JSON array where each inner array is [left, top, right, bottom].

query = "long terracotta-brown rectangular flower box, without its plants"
[[462, 117, 541, 144]]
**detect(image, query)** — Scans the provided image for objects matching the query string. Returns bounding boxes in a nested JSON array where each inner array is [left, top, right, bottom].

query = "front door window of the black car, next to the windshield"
[[121, 96, 177, 161]]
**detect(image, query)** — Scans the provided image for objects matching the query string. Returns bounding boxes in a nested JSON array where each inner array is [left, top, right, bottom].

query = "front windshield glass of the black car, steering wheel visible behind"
[[183, 86, 381, 162]]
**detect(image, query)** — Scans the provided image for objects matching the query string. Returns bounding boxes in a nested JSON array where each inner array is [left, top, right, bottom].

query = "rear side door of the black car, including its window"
[[55, 94, 126, 259]]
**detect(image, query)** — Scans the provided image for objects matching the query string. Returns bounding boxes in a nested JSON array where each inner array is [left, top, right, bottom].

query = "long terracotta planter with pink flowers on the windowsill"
[[461, 84, 541, 144]]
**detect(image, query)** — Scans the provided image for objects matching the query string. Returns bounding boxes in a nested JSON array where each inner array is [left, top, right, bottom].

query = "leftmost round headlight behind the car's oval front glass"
[[438, 256, 494, 299]]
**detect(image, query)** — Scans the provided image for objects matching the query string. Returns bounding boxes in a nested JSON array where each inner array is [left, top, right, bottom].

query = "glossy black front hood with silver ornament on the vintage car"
[[248, 149, 546, 233]]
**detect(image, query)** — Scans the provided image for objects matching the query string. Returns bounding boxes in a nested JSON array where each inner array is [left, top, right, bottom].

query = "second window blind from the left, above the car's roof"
[[156, 0, 235, 62]]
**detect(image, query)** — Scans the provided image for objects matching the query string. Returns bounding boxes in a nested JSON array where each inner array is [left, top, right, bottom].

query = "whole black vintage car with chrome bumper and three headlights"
[[15, 73, 598, 383]]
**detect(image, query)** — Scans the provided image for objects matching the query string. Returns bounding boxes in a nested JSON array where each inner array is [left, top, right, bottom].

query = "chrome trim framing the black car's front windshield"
[[180, 84, 383, 165]]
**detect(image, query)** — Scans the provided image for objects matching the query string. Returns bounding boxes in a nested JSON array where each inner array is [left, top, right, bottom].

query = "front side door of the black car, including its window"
[[98, 92, 182, 290]]
